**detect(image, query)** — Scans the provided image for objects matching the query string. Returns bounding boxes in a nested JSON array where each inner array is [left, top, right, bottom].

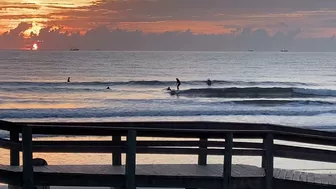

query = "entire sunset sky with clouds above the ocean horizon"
[[0, 0, 336, 51]]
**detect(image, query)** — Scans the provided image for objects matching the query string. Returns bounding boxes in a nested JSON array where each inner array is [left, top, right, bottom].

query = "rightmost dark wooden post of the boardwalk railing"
[[262, 133, 274, 189]]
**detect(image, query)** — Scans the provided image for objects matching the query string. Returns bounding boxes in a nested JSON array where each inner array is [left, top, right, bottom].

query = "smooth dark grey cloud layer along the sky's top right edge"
[[84, 0, 336, 21]]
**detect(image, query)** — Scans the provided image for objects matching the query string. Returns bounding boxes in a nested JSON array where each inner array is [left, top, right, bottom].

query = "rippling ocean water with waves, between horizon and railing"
[[0, 51, 336, 130]]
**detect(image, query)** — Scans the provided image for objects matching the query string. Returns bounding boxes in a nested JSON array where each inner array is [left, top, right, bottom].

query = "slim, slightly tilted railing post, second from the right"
[[223, 133, 233, 189]]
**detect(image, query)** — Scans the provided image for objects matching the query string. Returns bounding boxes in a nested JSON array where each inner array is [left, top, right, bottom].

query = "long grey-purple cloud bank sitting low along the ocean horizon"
[[0, 23, 336, 51]]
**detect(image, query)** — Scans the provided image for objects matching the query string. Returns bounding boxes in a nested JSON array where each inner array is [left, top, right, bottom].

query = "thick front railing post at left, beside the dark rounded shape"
[[22, 127, 34, 189]]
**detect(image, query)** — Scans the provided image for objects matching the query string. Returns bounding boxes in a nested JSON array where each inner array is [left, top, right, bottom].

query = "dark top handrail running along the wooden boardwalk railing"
[[0, 121, 336, 145]]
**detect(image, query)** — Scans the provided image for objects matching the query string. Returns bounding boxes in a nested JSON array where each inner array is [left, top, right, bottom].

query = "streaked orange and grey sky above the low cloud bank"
[[0, 0, 336, 38]]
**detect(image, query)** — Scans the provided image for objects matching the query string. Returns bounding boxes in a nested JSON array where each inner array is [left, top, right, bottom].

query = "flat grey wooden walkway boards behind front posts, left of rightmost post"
[[0, 164, 264, 179]]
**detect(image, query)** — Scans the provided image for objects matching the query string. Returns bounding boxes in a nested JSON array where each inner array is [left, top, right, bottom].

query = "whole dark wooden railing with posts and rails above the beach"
[[0, 121, 336, 189]]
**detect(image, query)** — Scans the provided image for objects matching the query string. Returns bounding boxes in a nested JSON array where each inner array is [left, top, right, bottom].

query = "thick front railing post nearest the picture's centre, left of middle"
[[125, 130, 136, 189]]
